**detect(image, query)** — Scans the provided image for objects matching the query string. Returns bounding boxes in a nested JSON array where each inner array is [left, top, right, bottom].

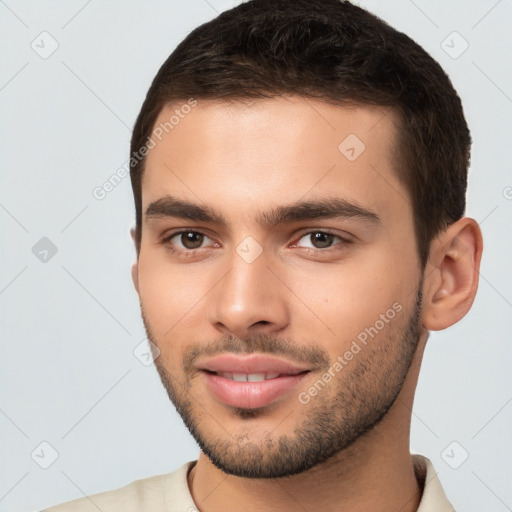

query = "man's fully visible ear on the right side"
[[422, 217, 483, 331]]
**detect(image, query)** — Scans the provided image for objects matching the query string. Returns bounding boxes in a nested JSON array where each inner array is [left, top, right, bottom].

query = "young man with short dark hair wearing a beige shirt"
[[46, 0, 482, 512]]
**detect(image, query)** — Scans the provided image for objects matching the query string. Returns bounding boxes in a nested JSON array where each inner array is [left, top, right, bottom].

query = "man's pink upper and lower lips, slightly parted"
[[197, 354, 310, 409]]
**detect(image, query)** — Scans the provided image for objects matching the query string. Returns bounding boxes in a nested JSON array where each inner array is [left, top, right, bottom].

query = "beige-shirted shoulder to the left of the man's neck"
[[42, 461, 197, 512]]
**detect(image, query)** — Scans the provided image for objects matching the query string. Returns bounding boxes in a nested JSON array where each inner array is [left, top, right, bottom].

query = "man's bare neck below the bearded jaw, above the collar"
[[189, 330, 426, 512]]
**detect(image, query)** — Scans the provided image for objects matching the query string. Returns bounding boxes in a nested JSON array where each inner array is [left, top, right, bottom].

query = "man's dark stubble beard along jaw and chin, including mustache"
[[142, 279, 423, 478]]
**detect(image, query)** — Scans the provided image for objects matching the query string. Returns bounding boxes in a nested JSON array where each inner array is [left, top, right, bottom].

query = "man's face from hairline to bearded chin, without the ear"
[[134, 96, 422, 477]]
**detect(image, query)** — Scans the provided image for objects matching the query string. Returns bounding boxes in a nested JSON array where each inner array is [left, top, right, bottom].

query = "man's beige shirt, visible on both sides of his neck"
[[43, 455, 454, 512]]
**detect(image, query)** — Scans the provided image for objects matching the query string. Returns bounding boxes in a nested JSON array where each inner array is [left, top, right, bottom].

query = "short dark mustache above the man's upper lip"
[[183, 333, 330, 371]]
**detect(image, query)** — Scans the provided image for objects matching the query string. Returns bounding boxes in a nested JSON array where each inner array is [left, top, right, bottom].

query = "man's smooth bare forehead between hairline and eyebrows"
[[142, 96, 411, 224]]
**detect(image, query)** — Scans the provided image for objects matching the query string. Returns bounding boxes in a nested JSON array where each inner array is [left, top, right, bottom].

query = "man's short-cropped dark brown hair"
[[130, 0, 471, 267]]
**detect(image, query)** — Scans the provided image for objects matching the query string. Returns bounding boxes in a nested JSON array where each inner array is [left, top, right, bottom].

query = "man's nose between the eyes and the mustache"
[[209, 246, 290, 337]]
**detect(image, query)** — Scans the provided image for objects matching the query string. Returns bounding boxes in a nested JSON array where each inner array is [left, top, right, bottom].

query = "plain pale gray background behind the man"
[[0, 0, 512, 512]]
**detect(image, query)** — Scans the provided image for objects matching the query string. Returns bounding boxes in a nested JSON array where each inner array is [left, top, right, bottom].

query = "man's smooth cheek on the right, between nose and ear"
[[287, 248, 418, 357]]
